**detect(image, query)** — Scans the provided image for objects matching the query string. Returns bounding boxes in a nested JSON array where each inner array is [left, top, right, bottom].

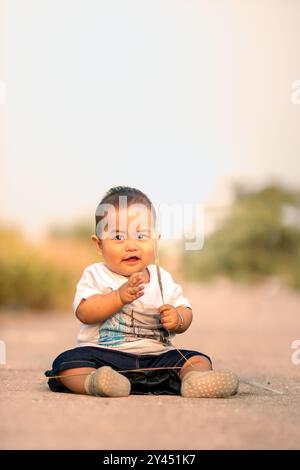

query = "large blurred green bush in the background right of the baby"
[[182, 186, 300, 289]]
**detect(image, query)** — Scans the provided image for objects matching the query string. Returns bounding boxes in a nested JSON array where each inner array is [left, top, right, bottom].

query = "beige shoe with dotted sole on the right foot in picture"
[[181, 370, 239, 398]]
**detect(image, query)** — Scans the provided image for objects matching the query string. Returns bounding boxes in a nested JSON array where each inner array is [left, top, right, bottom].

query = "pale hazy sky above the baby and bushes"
[[0, 0, 300, 241]]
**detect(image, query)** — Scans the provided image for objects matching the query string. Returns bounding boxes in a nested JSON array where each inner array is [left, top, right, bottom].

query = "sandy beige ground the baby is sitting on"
[[0, 281, 300, 450]]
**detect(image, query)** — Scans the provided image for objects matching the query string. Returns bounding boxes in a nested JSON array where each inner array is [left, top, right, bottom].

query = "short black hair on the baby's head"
[[95, 186, 156, 235]]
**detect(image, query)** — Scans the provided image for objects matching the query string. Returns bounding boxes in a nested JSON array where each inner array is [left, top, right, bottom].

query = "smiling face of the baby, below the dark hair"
[[94, 207, 157, 277]]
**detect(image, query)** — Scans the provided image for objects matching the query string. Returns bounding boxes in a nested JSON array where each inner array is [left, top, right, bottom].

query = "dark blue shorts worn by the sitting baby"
[[45, 346, 211, 395]]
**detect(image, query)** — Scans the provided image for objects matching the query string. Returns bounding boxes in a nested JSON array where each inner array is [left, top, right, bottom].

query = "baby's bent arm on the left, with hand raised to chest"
[[76, 273, 144, 324]]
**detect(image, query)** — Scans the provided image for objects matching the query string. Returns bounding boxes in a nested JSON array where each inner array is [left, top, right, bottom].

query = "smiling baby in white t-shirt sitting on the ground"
[[45, 186, 239, 398]]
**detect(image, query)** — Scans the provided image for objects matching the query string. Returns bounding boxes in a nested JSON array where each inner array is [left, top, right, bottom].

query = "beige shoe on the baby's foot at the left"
[[84, 366, 131, 397]]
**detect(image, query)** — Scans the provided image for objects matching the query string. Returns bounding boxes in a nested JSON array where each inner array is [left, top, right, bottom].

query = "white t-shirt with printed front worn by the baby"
[[73, 263, 191, 354]]
